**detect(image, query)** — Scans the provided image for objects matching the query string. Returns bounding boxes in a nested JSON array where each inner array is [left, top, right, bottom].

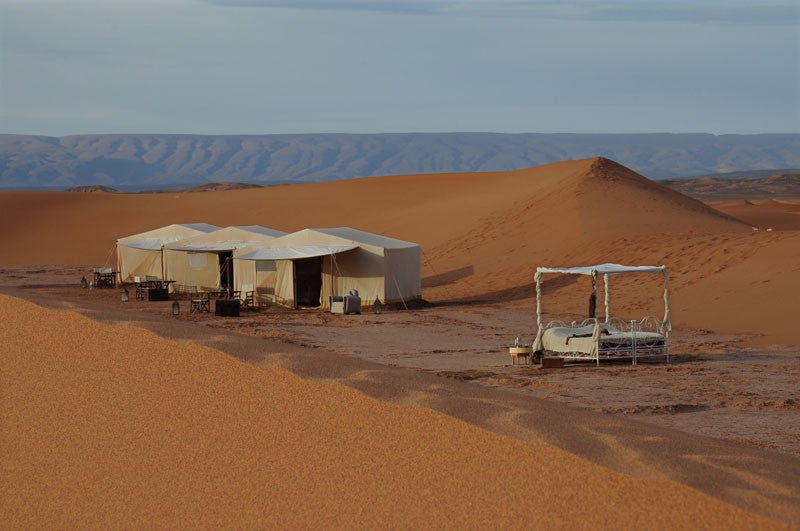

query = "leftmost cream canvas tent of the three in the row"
[[117, 223, 219, 282]]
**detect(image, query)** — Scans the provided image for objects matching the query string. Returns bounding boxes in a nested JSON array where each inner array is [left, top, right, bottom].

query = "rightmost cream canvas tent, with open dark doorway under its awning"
[[234, 227, 422, 308]]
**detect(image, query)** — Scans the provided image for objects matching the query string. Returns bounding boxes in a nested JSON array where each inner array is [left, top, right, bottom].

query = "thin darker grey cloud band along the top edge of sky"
[[201, 0, 800, 25]]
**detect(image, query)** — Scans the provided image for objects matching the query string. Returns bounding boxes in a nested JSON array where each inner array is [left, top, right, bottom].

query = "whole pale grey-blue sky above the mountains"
[[0, 0, 800, 136]]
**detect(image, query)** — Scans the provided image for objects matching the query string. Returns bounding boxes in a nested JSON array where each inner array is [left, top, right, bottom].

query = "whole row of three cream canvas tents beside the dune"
[[117, 224, 422, 309]]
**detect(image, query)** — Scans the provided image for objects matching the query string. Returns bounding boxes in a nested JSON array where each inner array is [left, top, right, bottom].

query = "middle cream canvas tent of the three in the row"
[[164, 225, 286, 291]]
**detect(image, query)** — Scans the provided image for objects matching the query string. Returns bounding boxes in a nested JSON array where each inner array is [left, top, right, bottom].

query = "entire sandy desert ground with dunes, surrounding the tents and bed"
[[0, 158, 800, 528]]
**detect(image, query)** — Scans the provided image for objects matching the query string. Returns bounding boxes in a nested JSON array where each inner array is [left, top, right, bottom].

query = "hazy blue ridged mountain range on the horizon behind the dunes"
[[0, 133, 800, 190]]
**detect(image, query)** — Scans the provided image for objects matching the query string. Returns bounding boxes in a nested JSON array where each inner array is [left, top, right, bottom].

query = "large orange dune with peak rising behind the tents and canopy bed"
[[0, 158, 800, 344]]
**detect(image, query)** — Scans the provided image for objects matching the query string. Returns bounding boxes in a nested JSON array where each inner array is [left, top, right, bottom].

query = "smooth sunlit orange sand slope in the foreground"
[[0, 296, 778, 529]]
